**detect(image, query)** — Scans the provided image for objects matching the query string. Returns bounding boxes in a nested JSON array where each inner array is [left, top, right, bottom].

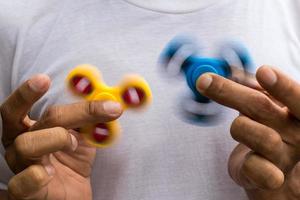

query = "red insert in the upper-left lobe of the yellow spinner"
[[72, 76, 93, 95]]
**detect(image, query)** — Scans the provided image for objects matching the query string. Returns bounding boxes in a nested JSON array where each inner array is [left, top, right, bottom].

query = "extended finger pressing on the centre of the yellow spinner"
[[31, 101, 122, 130]]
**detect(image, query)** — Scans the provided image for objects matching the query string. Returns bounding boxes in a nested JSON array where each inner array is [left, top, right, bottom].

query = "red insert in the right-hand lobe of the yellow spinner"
[[122, 87, 146, 106]]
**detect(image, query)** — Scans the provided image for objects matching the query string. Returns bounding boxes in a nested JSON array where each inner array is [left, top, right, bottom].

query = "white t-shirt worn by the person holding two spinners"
[[0, 0, 300, 200]]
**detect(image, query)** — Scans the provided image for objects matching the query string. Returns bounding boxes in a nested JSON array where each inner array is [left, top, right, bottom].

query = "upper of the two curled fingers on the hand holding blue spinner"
[[230, 116, 287, 167]]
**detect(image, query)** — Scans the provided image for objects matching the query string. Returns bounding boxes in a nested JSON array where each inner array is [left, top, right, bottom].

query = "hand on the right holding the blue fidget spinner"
[[197, 66, 300, 200]]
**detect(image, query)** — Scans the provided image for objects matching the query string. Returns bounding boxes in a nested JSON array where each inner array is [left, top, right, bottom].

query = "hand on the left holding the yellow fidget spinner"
[[0, 75, 122, 200]]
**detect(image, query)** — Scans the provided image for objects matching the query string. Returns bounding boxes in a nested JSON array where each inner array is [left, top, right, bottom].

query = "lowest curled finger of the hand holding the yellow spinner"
[[8, 165, 54, 199]]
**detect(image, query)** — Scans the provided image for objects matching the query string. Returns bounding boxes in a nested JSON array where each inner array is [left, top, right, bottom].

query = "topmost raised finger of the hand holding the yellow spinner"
[[0, 75, 50, 144]]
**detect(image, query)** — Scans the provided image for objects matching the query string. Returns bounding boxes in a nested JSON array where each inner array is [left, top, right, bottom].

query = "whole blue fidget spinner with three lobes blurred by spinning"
[[159, 36, 254, 126]]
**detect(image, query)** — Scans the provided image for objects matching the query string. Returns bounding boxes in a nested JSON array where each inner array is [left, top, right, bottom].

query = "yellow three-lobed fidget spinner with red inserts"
[[67, 64, 152, 148]]
